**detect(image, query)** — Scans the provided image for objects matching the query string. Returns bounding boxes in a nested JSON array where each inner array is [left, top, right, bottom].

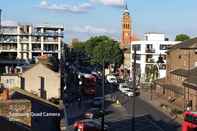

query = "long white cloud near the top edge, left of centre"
[[38, 0, 92, 13]]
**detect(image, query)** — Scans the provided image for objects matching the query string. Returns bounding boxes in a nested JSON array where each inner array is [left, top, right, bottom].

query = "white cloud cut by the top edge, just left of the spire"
[[90, 0, 124, 7]]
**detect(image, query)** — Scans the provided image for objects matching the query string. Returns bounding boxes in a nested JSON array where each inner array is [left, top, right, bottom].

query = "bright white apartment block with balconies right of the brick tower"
[[131, 33, 179, 81]]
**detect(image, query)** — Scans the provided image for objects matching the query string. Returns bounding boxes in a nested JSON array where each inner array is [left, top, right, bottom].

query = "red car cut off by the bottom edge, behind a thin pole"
[[73, 119, 109, 131]]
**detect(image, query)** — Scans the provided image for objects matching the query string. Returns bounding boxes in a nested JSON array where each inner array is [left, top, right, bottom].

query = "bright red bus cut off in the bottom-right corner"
[[182, 111, 197, 131]]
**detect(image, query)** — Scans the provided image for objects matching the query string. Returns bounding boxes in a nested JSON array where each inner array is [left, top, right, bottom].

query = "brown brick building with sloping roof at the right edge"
[[156, 38, 197, 110]]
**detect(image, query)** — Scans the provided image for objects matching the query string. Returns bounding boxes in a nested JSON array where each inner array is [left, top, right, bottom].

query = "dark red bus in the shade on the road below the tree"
[[81, 74, 96, 96]]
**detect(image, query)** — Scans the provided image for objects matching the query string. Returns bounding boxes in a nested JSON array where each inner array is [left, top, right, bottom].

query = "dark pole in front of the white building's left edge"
[[131, 46, 137, 131]]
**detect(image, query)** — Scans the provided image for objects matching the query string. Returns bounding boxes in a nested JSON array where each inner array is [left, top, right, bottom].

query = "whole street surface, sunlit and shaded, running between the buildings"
[[63, 78, 180, 131]]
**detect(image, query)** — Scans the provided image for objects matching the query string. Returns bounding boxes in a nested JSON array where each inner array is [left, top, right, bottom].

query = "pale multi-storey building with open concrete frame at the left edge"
[[0, 24, 64, 60]]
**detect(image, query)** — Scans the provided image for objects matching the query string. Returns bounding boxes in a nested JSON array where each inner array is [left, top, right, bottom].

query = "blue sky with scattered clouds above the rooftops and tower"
[[0, 0, 197, 43]]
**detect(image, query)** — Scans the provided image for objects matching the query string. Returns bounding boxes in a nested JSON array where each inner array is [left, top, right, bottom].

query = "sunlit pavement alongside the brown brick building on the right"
[[140, 89, 183, 124]]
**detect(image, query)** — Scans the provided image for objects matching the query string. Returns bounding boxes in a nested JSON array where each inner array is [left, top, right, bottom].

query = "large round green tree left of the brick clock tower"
[[73, 36, 124, 66]]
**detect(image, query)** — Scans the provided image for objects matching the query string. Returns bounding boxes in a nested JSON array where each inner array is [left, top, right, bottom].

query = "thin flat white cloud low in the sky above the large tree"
[[65, 25, 116, 34]]
